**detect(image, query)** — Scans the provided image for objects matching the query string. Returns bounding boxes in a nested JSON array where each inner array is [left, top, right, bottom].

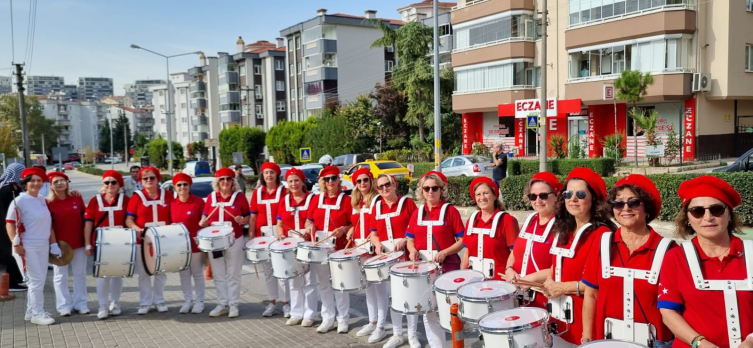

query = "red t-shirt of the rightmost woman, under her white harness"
[[658, 236, 753, 348]]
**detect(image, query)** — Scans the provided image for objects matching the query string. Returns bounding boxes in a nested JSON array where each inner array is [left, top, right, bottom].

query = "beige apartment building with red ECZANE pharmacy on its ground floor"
[[452, 0, 753, 160]]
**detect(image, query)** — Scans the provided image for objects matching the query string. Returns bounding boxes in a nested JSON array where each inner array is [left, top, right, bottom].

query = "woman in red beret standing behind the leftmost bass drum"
[[84, 170, 128, 319]]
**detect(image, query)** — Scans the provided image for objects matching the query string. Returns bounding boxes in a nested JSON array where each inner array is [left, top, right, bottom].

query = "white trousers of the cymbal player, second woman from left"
[[52, 248, 89, 312]]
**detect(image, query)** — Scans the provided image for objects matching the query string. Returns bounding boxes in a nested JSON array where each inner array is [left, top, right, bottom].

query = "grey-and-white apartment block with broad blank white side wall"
[[280, 9, 404, 121]]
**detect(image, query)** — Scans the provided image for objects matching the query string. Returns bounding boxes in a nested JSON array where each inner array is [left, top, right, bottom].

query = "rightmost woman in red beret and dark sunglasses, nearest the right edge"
[[658, 176, 753, 348]]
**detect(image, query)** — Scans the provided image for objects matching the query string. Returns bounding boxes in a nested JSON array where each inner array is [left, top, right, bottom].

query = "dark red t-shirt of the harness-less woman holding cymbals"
[[47, 195, 85, 250]]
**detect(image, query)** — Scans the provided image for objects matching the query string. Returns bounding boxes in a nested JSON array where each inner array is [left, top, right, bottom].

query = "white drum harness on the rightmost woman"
[[681, 240, 753, 347]]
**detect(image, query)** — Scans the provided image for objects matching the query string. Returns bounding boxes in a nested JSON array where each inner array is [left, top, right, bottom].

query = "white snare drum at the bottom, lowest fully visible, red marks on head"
[[478, 308, 548, 348]]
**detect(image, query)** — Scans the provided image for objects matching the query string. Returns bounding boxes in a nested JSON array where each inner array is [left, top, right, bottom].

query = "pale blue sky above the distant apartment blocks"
[[0, 0, 418, 95]]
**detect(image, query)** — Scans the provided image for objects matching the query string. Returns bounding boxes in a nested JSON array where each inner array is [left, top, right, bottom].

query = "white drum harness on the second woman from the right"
[[601, 232, 672, 347]]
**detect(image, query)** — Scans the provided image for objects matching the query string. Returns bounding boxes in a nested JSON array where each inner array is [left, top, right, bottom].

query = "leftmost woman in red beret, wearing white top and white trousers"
[[5, 168, 57, 325]]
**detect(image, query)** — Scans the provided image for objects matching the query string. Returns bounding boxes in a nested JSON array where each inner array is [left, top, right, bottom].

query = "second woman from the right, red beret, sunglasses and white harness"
[[581, 174, 676, 348]]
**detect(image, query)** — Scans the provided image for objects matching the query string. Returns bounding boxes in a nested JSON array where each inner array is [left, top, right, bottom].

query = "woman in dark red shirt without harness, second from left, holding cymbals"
[[47, 172, 89, 317]]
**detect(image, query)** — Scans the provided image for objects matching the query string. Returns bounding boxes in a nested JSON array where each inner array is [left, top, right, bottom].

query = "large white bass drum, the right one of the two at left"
[[141, 224, 191, 275]]
